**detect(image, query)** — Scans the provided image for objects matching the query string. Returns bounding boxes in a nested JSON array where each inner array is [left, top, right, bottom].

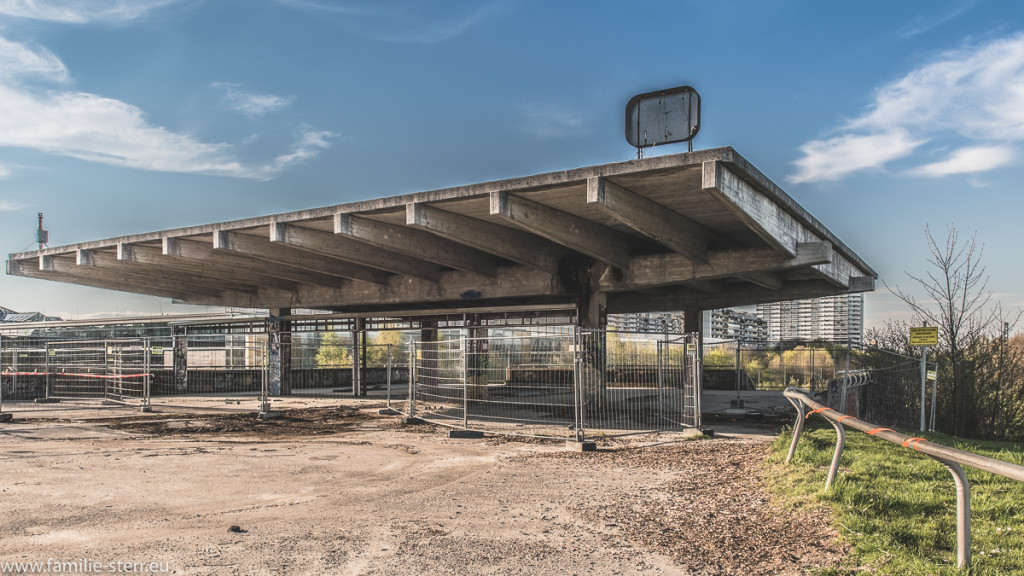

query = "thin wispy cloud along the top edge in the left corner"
[[0, 0, 177, 24]]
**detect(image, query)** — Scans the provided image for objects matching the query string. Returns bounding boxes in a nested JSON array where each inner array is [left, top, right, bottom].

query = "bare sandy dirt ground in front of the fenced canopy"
[[0, 402, 843, 576]]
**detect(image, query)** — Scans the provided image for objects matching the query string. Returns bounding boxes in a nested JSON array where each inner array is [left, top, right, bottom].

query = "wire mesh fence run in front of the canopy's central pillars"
[[407, 330, 700, 440]]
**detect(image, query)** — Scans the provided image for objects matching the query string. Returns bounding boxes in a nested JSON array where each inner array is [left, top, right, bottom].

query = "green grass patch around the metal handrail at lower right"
[[766, 421, 1024, 576]]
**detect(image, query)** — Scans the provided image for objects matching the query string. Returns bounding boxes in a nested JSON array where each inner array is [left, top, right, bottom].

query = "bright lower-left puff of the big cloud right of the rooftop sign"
[[790, 128, 924, 183]]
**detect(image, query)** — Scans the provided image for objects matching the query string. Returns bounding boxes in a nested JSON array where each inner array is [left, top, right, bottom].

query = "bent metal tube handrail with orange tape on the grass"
[[783, 387, 1024, 569]]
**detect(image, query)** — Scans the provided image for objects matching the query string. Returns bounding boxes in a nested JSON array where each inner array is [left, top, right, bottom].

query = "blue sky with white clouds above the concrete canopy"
[[0, 0, 1024, 326]]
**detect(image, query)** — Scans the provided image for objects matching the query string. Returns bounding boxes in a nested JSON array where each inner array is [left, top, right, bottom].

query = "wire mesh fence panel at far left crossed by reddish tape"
[[46, 339, 152, 406]]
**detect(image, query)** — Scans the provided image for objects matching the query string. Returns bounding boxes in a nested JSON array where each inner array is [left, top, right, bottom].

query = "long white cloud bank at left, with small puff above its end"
[[0, 31, 332, 179]]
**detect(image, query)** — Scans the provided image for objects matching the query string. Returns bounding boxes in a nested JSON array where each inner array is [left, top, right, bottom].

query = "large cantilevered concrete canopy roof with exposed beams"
[[7, 148, 878, 314]]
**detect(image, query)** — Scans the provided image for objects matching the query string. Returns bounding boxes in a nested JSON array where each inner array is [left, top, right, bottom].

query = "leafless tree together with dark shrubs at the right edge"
[[865, 227, 1024, 441]]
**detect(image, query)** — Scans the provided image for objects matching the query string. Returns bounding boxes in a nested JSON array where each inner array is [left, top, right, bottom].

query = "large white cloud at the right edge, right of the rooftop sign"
[[790, 34, 1024, 182]]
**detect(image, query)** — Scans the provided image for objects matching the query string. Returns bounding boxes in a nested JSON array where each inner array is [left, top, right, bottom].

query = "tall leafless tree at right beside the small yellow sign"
[[887, 225, 993, 436]]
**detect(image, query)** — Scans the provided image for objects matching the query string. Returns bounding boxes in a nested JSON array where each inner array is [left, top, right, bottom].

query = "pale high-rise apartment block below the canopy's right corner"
[[757, 294, 864, 343]]
